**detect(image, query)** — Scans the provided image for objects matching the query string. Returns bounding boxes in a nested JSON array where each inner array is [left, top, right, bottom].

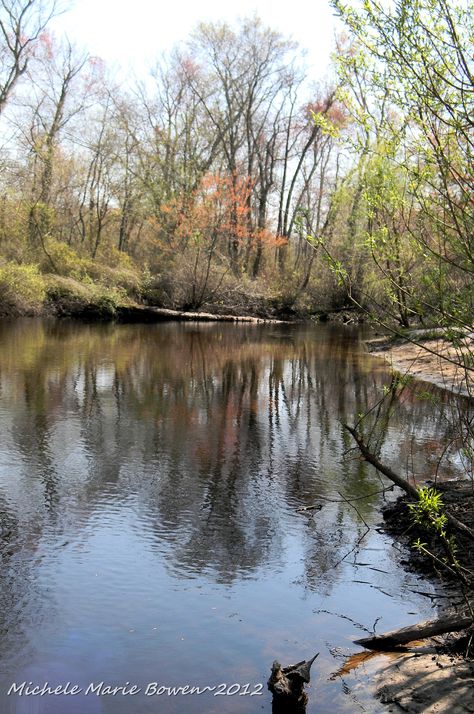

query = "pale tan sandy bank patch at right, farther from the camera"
[[366, 330, 474, 397]]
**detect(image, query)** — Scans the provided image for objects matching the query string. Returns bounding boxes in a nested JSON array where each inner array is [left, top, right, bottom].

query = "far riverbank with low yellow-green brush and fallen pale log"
[[0, 259, 364, 324]]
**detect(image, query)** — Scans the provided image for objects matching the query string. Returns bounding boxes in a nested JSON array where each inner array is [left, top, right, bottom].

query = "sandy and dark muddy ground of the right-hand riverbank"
[[354, 329, 474, 714]]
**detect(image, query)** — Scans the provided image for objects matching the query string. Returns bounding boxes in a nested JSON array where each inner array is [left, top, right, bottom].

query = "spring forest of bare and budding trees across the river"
[[0, 0, 474, 328]]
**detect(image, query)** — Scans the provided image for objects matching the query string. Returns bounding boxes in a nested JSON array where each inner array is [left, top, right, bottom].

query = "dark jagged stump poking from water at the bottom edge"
[[268, 652, 319, 714]]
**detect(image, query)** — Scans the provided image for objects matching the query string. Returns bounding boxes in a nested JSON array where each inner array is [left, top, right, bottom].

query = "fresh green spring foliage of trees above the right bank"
[[331, 0, 474, 326]]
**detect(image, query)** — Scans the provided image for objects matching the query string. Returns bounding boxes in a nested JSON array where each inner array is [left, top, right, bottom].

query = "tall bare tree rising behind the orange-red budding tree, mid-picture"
[[184, 18, 299, 274]]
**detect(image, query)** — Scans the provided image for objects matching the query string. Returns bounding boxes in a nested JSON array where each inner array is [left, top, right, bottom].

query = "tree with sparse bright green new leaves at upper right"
[[332, 0, 474, 326]]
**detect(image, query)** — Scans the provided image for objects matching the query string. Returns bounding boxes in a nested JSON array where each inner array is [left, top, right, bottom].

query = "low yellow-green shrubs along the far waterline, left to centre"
[[0, 263, 364, 323]]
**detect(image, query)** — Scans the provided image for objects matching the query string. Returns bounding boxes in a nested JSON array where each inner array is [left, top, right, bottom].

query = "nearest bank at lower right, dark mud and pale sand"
[[375, 481, 474, 714]]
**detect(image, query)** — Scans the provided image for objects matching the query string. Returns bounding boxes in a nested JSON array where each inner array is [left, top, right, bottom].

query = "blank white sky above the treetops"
[[50, 0, 336, 79]]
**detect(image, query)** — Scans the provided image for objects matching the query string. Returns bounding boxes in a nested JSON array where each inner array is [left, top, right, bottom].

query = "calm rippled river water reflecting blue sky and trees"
[[0, 320, 466, 714]]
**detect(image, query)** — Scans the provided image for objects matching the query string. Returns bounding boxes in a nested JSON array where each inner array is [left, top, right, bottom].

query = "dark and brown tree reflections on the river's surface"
[[0, 320, 466, 711]]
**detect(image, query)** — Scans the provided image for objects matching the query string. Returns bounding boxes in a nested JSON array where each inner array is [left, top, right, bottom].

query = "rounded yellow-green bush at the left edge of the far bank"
[[0, 263, 46, 316]]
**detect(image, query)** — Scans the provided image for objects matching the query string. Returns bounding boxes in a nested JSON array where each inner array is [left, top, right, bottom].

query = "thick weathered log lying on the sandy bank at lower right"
[[355, 613, 473, 650]]
